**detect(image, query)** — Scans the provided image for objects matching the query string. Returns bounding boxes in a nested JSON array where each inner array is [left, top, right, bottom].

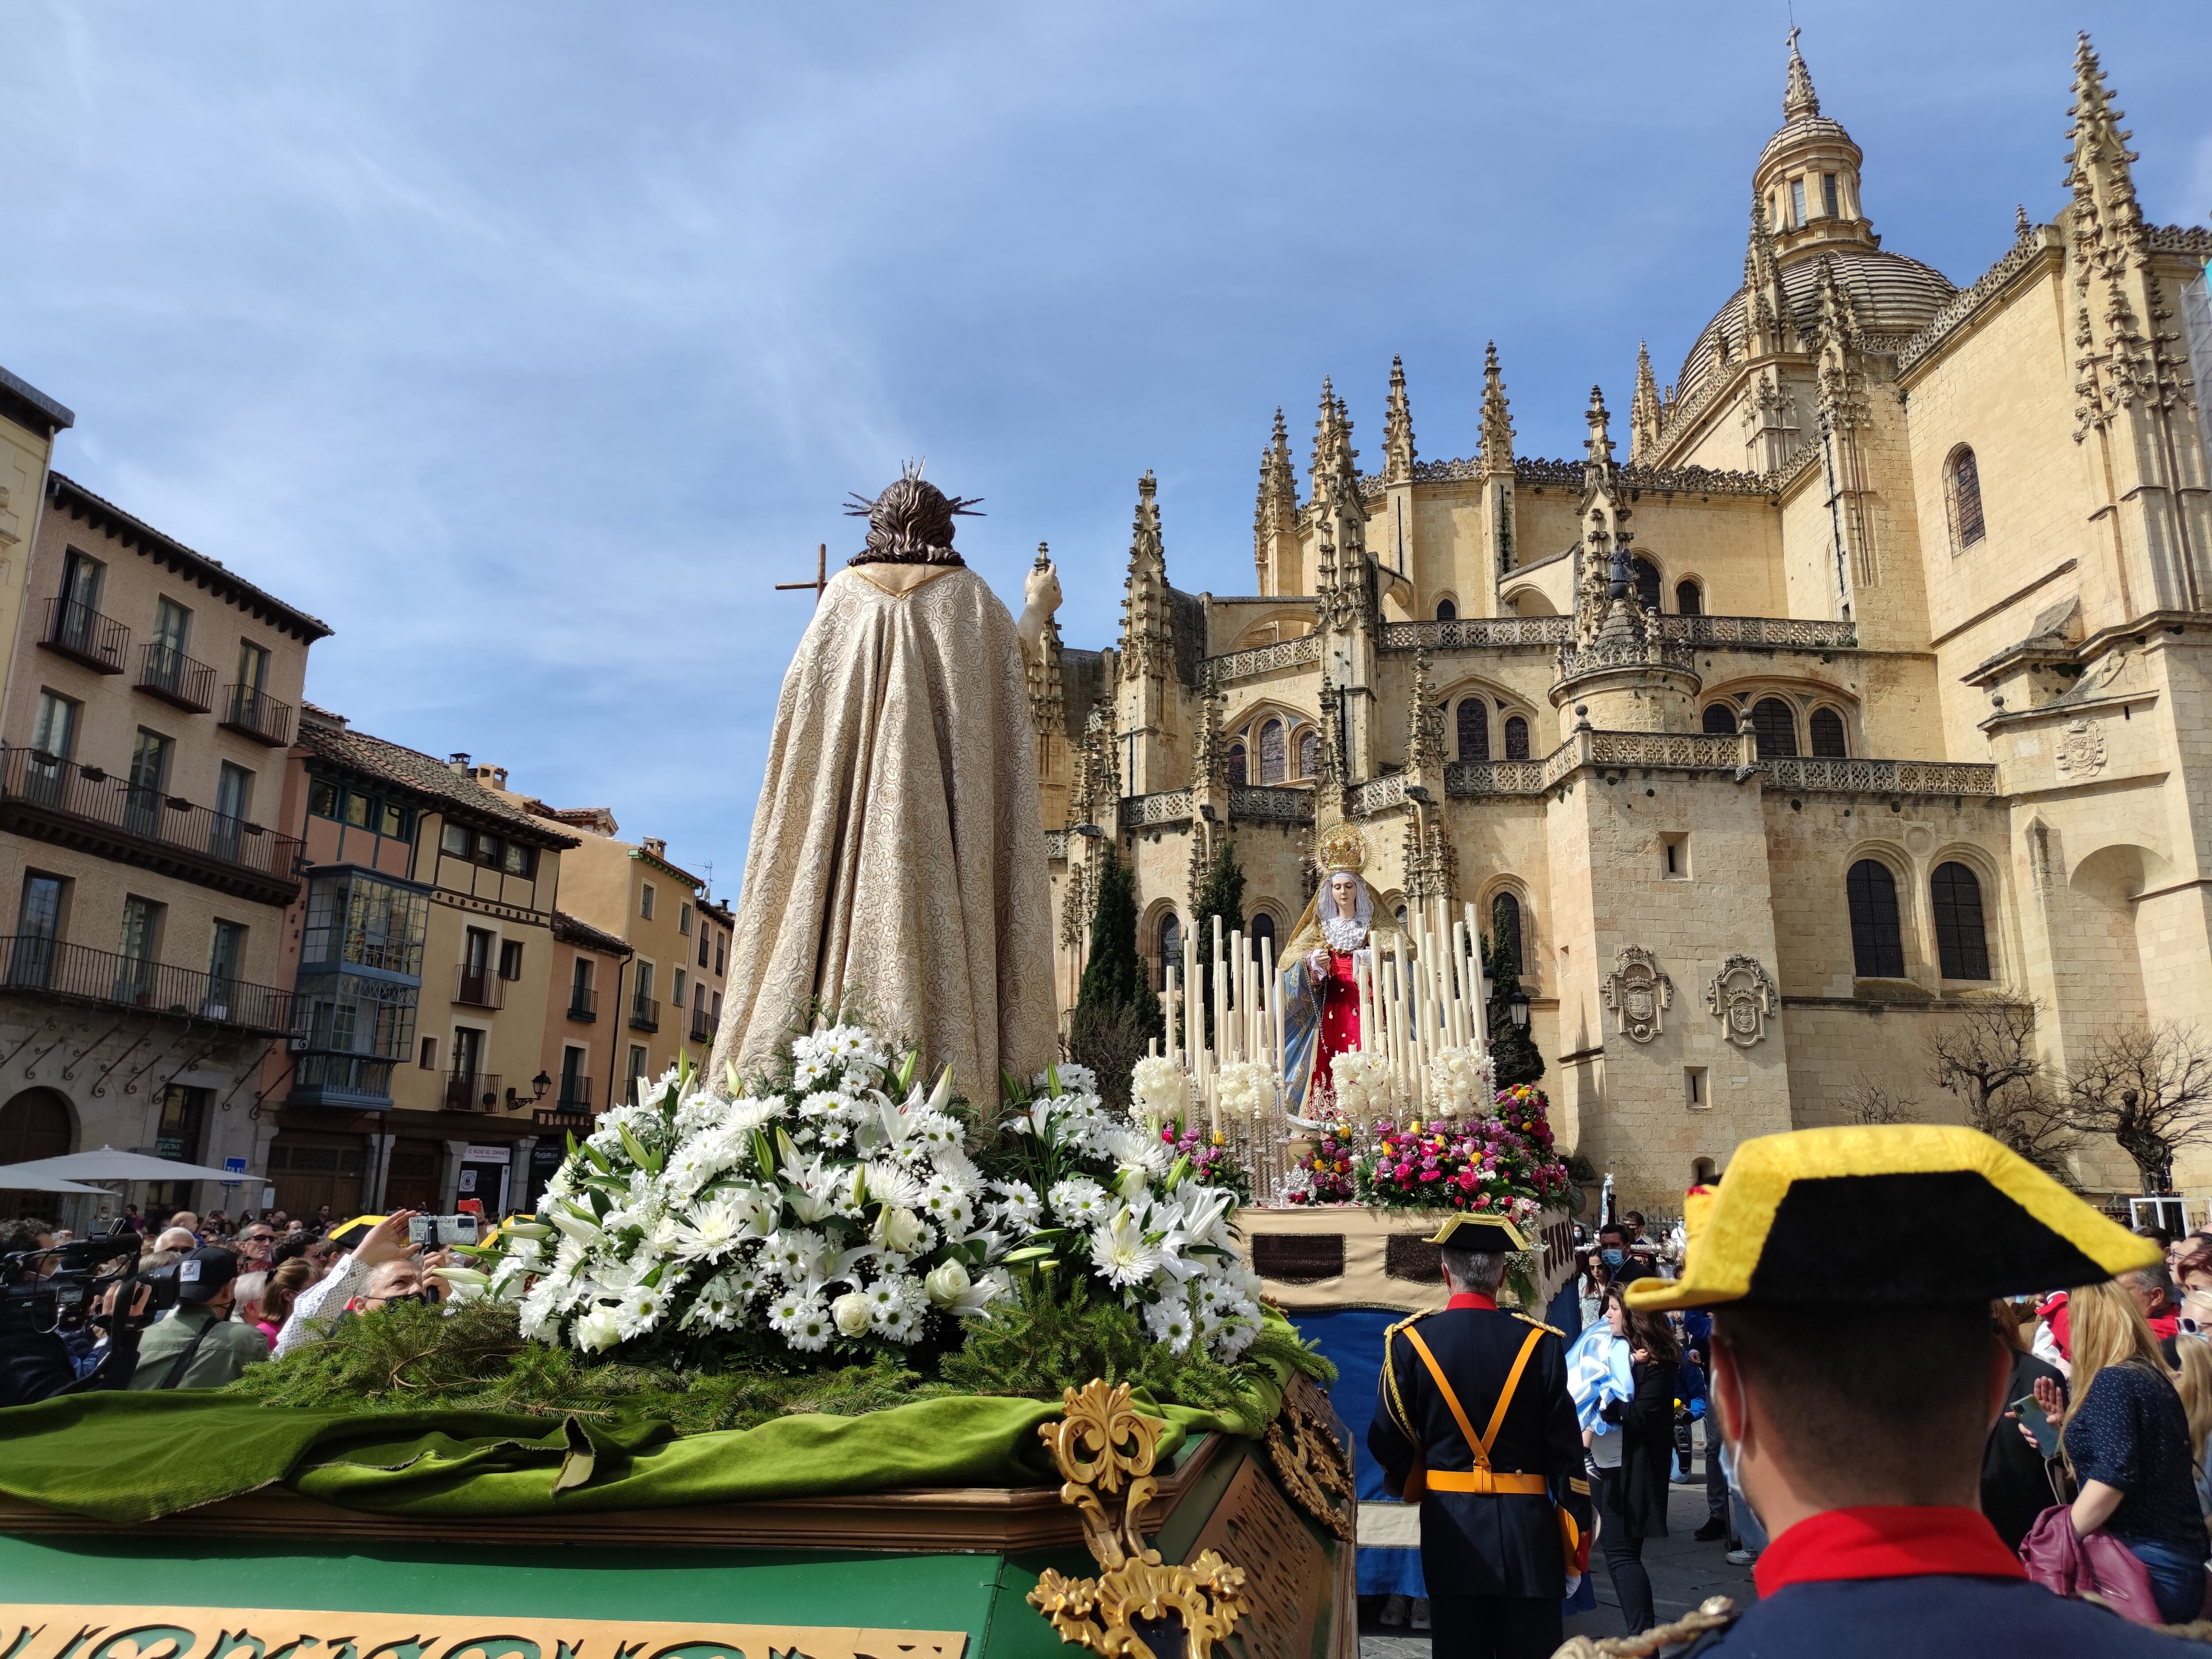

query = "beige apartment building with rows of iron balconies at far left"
[[0, 462, 330, 1210]]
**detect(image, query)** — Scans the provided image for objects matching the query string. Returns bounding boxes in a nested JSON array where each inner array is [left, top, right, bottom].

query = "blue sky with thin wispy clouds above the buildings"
[[0, 0, 2212, 911]]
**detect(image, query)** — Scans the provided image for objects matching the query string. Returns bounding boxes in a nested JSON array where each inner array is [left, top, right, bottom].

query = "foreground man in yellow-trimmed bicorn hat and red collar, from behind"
[[1628, 1124, 2181, 1659]]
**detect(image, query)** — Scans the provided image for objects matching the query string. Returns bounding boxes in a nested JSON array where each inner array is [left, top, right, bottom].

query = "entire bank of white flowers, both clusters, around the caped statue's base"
[[467, 1026, 1259, 1360]]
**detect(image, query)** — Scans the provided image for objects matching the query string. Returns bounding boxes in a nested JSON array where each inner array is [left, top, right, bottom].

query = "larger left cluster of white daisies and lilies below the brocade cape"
[[480, 1026, 1026, 1354]]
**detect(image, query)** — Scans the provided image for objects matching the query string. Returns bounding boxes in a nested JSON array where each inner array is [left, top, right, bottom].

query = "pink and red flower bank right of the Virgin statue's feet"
[[1356, 1086, 1566, 1223]]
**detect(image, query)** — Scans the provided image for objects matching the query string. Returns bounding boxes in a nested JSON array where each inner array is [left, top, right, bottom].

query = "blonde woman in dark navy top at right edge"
[[2035, 1283, 2205, 1624]]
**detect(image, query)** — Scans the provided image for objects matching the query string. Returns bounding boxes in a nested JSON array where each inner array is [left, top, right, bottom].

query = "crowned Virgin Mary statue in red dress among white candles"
[[1283, 825, 1398, 1115]]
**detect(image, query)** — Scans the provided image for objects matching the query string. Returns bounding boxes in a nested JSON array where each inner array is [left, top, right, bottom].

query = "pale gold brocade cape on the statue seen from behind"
[[708, 566, 1057, 1106]]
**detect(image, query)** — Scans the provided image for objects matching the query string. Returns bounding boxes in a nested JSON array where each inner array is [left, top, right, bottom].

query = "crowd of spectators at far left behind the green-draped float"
[[0, 1203, 451, 1405]]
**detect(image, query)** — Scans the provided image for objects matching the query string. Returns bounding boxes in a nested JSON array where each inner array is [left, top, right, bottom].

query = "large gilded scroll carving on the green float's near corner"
[[1029, 1380, 1245, 1659]]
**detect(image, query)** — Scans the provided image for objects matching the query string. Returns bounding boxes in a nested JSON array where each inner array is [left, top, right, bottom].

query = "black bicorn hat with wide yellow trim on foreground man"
[[1626, 1124, 2159, 1310]]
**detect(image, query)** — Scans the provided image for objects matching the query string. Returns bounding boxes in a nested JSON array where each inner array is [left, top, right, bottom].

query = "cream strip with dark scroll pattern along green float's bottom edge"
[[0, 1601, 967, 1659]]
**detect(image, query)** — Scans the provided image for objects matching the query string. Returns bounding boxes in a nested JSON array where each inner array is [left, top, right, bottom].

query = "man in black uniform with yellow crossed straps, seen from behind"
[[1367, 1217, 1590, 1659]]
